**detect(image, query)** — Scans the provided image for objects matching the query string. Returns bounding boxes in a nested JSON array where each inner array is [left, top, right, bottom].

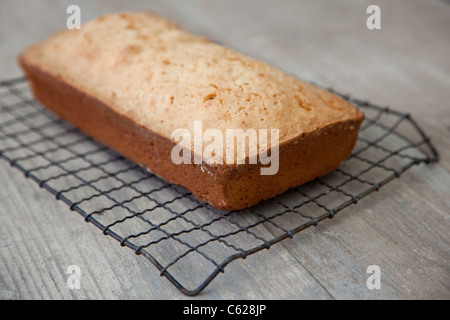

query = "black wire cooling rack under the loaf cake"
[[0, 78, 438, 295]]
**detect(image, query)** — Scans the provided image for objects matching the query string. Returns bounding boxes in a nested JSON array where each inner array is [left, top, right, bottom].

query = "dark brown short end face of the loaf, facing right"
[[221, 119, 361, 209]]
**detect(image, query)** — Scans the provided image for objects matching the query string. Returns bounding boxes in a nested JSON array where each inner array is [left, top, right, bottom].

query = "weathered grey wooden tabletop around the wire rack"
[[0, 0, 450, 299]]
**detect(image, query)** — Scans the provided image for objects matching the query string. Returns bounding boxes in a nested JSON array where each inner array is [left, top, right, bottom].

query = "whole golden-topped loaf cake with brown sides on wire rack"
[[19, 12, 364, 210]]
